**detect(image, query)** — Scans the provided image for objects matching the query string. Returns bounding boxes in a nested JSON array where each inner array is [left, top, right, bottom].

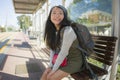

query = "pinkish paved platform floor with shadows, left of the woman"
[[0, 32, 72, 80]]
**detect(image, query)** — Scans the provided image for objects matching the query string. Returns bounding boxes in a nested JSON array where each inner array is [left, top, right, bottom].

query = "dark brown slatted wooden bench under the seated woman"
[[71, 36, 117, 80]]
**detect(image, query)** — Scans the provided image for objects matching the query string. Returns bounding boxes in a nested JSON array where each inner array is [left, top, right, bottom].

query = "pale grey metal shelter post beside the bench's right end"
[[109, 0, 120, 80]]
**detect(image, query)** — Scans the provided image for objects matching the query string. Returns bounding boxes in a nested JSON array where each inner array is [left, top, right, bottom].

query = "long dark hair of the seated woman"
[[44, 5, 71, 50]]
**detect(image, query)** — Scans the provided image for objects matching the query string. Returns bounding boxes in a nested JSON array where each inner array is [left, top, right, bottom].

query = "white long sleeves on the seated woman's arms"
[[50, 27, 77, 71]]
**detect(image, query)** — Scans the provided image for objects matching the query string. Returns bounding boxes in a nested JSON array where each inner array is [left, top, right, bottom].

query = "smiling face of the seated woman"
[[51, 7, 64, 26]]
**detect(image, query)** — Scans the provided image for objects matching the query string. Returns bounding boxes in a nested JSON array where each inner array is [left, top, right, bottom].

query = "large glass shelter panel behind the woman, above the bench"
[[66, 0, 112, 35]]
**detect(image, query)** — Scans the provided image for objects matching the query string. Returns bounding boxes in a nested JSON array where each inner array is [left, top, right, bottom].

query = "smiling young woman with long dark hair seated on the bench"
[[40, 5, 83, 80]]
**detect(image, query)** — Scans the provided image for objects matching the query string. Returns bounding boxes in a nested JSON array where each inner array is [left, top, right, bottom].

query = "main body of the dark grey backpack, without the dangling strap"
[[71, 23, 94, 56]]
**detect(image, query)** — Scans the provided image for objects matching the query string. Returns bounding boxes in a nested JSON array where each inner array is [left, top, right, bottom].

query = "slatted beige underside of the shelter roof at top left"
[[13, 0, 46, 14]]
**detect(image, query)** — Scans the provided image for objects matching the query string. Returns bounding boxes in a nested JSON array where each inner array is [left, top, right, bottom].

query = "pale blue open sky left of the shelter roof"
[[0, 0, 19, 27]]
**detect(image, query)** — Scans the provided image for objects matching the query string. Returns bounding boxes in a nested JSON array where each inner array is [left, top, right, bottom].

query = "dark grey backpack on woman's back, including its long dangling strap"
[[71, 23, 98, 80]]
